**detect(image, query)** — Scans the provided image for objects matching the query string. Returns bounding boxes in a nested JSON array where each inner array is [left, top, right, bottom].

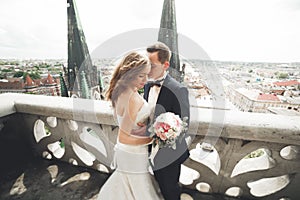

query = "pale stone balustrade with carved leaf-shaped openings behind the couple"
[[0, 94, 300, 199]]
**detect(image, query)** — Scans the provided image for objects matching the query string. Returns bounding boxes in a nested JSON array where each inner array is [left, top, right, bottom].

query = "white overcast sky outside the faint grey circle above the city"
[[0, 0, 300, 62]]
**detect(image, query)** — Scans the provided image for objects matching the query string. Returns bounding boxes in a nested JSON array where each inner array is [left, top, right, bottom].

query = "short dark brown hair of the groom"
[[147, 42, 171, 63]]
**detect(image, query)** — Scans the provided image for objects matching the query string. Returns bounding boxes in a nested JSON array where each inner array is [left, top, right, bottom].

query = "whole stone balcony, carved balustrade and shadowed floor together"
[[0, 93, 300, 200]]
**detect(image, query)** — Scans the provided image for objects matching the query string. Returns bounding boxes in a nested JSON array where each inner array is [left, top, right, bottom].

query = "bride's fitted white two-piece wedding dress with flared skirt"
[[98, 101, 163, 200]]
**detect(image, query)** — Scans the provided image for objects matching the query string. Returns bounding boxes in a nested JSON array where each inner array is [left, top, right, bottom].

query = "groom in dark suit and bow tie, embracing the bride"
[[144, 42, 190, 200]]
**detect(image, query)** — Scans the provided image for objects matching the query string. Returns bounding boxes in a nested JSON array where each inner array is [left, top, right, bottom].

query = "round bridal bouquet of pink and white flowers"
[[148, 112, 188, 149]]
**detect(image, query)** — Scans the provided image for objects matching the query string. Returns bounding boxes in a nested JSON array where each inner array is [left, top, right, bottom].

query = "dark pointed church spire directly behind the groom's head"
[[158, 0, 180, 80]]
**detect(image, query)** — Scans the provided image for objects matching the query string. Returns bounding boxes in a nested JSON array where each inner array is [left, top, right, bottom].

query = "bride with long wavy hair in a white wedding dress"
[[98, 52, 162, 200]]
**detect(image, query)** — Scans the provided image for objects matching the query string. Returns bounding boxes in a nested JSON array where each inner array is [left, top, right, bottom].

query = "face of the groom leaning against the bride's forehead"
[[148, 52, 169, 80]]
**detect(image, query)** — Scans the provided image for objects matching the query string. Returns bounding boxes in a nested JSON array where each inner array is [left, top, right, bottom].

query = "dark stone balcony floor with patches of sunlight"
[[0, 159, 244, 200]]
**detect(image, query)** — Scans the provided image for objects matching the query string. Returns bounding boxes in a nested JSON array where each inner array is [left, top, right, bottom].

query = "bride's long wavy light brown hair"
[[106, 52, 150, 107]]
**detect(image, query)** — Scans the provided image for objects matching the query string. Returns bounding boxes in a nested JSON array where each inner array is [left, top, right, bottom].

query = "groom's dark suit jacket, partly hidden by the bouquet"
[[144, 74, 190, 170]]
